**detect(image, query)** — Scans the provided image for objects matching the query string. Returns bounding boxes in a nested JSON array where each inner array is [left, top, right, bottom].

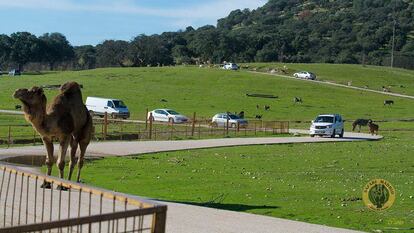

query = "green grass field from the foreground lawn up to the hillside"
[[4, 64, 414, 232]]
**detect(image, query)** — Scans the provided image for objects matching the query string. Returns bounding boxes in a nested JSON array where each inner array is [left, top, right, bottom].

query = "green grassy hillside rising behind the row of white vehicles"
[[0, 64, 414, 123]]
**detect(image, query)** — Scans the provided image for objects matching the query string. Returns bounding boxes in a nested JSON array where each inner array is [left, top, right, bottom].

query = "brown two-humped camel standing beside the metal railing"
[[13, 82, 93, 188]]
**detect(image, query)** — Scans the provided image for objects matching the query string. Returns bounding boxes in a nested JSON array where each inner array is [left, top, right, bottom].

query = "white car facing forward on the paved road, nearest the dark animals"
[[309, 114, 344, 138]]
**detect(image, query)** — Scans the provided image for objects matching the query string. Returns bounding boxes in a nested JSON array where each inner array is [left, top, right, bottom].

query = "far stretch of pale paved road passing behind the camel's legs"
[[0, 129, 381, 159]]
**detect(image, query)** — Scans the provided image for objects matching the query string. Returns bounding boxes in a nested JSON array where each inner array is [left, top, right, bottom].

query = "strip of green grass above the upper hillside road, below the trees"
[[246, 63, 414, 95]]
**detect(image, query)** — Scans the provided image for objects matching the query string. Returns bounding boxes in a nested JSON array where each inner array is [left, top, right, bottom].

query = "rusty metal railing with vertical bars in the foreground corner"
[[0, 165, 167, 233]]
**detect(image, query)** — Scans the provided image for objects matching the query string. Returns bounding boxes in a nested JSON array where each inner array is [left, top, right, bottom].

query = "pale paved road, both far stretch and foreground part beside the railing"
[[0, 130, 381, 233]]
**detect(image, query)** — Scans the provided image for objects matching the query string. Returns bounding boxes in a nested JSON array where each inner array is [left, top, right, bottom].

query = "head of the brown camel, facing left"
[[13, 87, 47, 114]]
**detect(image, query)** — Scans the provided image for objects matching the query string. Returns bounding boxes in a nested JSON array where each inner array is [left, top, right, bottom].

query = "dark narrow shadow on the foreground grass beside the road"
[[160, 201, 280, 212]]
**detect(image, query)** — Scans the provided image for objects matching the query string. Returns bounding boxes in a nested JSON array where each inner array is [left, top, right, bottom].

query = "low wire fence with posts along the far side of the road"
[[0, 112, 289, 146]]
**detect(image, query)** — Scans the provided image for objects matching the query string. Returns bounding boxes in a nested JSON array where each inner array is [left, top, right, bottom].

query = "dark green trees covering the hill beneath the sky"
[[0, 0, 414, 69]]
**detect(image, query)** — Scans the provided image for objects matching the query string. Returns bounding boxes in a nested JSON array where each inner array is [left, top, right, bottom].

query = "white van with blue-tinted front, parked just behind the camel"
[[85, 97, 130, 119]]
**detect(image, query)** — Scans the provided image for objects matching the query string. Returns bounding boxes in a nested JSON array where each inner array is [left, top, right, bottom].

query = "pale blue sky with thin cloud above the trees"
[[0, 0, 267, 46]]
